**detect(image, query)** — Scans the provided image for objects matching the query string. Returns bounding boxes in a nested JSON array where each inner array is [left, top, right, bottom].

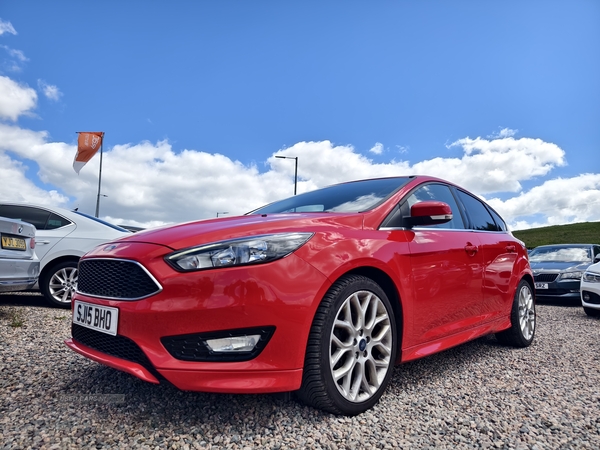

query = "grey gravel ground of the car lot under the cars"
[[0, 296, 600, 450]]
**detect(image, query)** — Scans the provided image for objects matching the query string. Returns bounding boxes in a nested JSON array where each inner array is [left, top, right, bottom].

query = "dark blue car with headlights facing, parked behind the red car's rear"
[[529, 244, 600, 302]]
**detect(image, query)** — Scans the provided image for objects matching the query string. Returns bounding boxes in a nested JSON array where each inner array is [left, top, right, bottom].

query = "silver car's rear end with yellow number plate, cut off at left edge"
[[0, 217, 40, 292]]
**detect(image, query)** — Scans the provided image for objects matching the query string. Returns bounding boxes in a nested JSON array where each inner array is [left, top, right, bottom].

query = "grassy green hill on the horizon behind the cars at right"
[[512, 222, 600, 248]]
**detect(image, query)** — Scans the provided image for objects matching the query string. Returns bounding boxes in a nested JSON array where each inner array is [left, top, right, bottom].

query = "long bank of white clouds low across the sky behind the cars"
[[0, 123, 600, 229]]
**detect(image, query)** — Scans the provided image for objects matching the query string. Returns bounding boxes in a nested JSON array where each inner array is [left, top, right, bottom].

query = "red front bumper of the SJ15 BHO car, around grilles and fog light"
[[65, 246, 329, 393]]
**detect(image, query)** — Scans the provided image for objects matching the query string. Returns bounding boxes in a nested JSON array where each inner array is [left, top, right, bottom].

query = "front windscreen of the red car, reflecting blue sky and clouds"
[[248, 177, 410, 214]]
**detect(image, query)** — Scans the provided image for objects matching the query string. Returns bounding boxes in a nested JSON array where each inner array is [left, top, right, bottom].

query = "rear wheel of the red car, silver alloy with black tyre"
[[496, 280, 536, 348]]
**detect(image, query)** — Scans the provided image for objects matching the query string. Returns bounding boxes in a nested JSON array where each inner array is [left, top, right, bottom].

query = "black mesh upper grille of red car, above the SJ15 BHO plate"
[[77, 259, 162, 300]]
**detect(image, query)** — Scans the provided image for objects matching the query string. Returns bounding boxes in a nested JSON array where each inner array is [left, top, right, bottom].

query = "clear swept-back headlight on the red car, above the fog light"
[[165, 233, 313, 272]]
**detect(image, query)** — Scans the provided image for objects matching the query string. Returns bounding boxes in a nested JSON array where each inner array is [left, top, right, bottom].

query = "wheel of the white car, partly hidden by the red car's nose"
[[40, 261, 77, 308]]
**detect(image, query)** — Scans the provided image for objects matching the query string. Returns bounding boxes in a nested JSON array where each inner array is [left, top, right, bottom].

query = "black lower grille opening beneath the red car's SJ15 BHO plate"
[[71, 324, 158, 376]]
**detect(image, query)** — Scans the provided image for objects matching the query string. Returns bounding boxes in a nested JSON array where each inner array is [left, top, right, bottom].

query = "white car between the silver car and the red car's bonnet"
[[0, 202, 131, 308]]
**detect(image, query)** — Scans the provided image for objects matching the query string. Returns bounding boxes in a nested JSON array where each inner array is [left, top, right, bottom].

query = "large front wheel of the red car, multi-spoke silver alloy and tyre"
[[298, 275, 397, 416]]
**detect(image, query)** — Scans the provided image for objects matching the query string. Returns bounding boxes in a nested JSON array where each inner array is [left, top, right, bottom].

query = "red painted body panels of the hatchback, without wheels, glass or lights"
[[66, 177, 533, 393]]
